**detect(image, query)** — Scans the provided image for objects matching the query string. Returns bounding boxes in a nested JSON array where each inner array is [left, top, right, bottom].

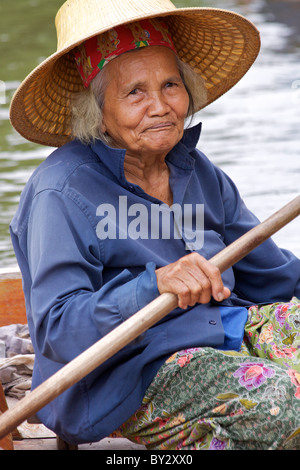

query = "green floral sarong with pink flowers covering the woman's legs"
[[119, 298, 300, 450]]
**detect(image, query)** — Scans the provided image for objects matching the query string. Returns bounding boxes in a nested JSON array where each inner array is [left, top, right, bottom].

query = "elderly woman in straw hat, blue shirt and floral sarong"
[[11, 0, 300, 449]]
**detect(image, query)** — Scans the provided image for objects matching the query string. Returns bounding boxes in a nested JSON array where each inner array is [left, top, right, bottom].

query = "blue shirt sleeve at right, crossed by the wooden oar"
[[217, 167, 300, 303]]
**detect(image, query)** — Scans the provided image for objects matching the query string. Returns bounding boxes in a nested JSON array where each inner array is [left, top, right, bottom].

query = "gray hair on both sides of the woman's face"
[[71, 56, 207, 146]]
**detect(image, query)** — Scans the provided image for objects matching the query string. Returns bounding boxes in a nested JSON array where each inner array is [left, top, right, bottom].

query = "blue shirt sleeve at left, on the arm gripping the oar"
[[27, 190, 159, 363]]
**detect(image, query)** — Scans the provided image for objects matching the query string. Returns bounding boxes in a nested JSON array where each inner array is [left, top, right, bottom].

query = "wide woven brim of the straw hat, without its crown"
[[10, 8, 260, 147]]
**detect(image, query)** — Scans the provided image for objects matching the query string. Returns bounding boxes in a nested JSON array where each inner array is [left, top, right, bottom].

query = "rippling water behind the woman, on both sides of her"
[[0, 0, 300, 271]]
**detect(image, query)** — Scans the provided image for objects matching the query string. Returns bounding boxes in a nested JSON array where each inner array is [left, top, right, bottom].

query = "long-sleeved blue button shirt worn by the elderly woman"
[[11, 126, 300, 443]]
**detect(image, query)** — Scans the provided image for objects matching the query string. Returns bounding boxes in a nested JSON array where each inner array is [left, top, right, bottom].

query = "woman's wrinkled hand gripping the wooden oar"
[[155, 253, 230, 309]]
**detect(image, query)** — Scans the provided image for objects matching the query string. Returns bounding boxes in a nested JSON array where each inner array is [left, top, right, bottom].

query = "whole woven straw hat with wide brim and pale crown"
[[10, 0, 260, 147]]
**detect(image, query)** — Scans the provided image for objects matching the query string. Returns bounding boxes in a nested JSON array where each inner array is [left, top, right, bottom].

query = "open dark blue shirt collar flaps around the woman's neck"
[[91, 123, 202, 187]]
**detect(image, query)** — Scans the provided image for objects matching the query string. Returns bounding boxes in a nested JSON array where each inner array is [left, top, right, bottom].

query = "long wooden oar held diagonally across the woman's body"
[[0, 196, 300, 439]]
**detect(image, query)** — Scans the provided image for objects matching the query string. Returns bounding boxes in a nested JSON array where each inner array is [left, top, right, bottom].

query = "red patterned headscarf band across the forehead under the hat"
[[74, 18, 176, 88]]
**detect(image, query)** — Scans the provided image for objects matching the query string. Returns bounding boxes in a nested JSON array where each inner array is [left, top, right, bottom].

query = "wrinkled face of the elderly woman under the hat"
[[102, 46, 189, 158]]
